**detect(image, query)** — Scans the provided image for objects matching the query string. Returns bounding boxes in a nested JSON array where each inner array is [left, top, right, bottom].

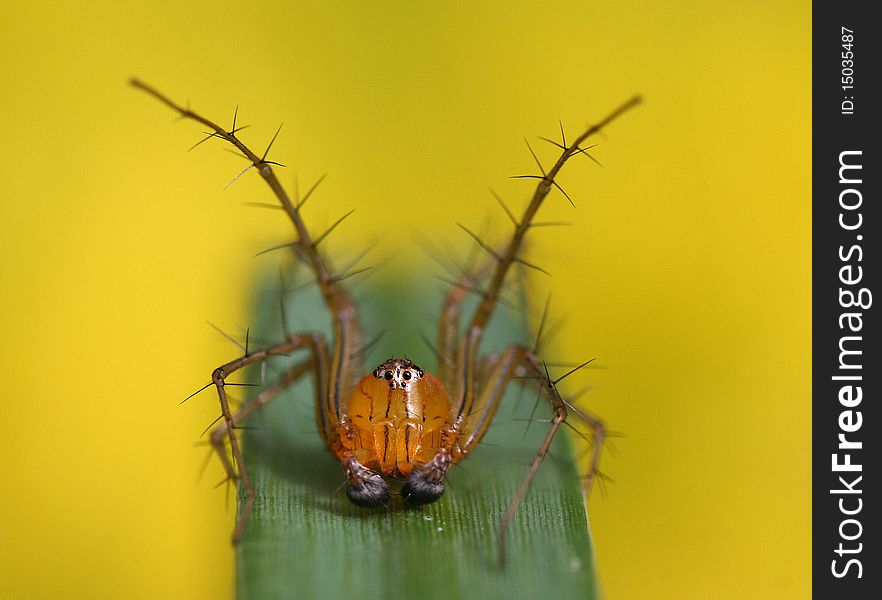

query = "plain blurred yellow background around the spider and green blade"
[[0, 0, 811, 599]]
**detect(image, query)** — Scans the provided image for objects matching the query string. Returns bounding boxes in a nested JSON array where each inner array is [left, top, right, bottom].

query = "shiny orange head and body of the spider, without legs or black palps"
[[340, 359, 450, 477]]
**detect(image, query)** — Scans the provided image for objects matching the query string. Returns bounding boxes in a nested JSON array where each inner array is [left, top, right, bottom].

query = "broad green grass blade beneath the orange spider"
[[237, 272, 597, 600]]
